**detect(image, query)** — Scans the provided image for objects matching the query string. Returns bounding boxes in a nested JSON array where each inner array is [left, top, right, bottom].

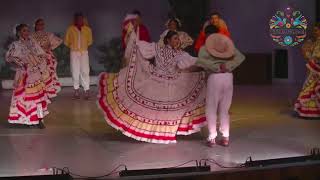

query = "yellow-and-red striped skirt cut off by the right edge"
[[294, 60, 320, 118]]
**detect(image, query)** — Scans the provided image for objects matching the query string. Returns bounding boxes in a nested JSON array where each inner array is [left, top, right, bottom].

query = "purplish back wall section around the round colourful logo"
[[211, 0, 316, 84]]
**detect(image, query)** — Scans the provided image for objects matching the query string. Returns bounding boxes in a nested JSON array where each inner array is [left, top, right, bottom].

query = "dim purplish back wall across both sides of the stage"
[[0, 0, 316, 84]]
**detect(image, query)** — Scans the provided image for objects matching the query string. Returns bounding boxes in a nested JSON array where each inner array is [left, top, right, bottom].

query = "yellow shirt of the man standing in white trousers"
[[64, 25, 92, 52]]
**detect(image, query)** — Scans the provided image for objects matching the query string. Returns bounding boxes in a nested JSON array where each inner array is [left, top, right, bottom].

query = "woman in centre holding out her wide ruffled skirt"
[[98, 31, 206, 144]]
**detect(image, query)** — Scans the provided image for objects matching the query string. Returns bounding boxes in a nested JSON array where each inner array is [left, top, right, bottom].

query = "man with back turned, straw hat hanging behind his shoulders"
[[178, 25, 245, 147]]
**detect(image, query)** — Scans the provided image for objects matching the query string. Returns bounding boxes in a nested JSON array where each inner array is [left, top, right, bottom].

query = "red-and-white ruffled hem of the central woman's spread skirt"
[[97, 73, 206, 144]]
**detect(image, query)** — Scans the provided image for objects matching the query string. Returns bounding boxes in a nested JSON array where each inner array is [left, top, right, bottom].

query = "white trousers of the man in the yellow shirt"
[[70, 51, 90, 91]]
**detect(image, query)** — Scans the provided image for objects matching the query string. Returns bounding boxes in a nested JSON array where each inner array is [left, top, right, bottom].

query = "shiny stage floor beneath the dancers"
[[0, 85, 320, 176]]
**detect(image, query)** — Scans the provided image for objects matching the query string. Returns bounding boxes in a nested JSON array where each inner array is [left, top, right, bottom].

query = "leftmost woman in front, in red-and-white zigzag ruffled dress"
[[6, 24, 51, 128]]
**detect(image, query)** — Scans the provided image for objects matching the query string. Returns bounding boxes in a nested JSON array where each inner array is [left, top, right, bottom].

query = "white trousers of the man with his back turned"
[[206, 73, 233, 140]]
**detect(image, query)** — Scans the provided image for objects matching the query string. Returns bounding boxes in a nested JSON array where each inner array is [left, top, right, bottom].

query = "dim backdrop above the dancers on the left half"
[[0, 0, 170, 77]]
